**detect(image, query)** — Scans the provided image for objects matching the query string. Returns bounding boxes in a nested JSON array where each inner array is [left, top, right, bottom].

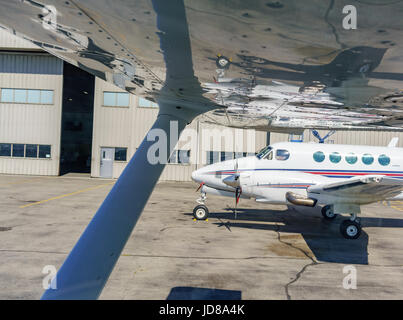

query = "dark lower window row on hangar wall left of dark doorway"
[[0, 143, 51, 159]]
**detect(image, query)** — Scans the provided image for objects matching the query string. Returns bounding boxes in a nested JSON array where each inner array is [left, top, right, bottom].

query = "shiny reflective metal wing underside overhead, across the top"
[[0, 0, 403, 132]]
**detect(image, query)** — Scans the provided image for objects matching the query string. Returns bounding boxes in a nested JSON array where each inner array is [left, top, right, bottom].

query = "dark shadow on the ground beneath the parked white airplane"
[[187, 208, 403, 264]]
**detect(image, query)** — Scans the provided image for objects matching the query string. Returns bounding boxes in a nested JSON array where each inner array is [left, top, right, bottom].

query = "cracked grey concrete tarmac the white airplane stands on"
[[0, 175, 403, 299]]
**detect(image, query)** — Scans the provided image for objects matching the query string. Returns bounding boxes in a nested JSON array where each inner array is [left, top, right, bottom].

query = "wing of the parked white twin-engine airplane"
[[307, 175, 403, 202]]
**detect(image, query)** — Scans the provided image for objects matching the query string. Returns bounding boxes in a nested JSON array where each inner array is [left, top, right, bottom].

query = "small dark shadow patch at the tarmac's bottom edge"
[[167, 287, 242, 300]]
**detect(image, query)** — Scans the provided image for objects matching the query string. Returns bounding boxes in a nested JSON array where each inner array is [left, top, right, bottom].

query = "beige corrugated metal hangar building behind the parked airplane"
[[0, 30, 403, 181]]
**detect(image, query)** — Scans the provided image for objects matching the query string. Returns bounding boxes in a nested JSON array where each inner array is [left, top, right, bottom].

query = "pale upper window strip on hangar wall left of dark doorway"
[[0, 88, 54, 104]]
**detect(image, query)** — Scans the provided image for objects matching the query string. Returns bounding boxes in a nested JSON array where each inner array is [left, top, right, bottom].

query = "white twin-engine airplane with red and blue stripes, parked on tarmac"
[[192, 138, 403, 239]]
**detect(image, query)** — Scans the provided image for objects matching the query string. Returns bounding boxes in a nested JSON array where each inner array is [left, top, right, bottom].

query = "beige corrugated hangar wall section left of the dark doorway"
[[0, 52, 63, 175]]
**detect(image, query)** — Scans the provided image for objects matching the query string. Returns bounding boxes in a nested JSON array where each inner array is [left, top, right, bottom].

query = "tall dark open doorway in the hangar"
[[60, 62, 95, 175]]
